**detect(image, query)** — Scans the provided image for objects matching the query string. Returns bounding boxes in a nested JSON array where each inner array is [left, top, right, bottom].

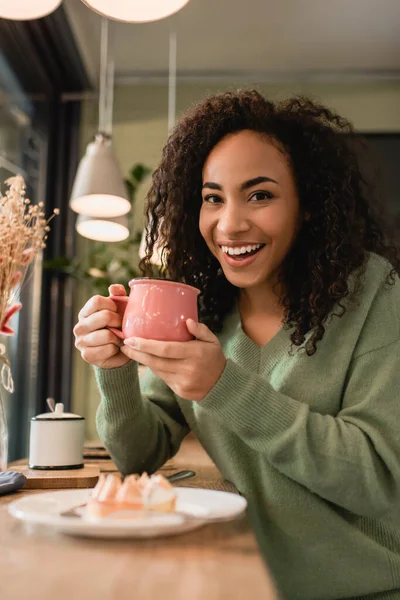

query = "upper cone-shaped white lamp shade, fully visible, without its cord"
[[70, 135, 131, 218]]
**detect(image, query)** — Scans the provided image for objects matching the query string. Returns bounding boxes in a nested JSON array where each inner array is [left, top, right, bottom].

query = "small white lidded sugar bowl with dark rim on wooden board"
[[29, 403, 85, 469]]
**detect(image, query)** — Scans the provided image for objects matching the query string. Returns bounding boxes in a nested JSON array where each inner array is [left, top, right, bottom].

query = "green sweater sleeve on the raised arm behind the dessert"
[[95, 361, 189, 475]]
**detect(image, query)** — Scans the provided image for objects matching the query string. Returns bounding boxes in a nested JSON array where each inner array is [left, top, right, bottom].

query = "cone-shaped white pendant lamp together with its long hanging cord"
[[70, 19, 131, 232]]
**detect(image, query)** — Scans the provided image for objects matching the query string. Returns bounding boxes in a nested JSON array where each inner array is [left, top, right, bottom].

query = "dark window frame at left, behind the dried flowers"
[[0, 6, 91, 440]]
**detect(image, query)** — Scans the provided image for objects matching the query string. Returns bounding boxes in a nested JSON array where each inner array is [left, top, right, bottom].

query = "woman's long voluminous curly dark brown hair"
[[140, 90, 400, 355]]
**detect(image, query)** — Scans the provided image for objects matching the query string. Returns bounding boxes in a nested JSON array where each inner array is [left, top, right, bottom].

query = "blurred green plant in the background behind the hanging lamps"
[[44, 163, 151, 295]]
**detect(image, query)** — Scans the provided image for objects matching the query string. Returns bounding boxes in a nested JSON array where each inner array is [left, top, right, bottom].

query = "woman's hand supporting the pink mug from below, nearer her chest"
[[121, 319, 226, 401]]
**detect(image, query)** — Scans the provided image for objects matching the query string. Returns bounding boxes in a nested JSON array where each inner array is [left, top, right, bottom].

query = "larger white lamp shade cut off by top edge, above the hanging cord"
[[82, 0, 189, 23]]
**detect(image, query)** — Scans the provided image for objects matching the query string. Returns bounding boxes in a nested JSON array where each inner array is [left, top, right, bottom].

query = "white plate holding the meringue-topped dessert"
[[8, 488, 247, 538]]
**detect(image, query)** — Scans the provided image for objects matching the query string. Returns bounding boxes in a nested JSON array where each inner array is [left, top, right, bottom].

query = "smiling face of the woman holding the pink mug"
[[200, 130, 301, 291]]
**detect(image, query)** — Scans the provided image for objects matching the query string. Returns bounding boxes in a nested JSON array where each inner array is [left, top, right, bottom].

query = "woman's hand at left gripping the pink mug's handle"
[[74, 285, 130, 369]]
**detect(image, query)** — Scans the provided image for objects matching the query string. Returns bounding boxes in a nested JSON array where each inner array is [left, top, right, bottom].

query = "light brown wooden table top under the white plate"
[[0, 439, 276, 600]]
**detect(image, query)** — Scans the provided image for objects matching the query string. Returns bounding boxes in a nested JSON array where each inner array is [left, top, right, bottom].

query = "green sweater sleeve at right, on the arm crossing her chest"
[[200, 341, 400, 517]]
